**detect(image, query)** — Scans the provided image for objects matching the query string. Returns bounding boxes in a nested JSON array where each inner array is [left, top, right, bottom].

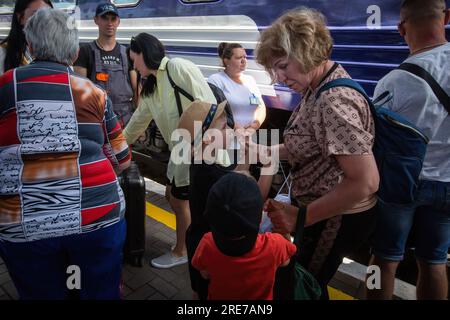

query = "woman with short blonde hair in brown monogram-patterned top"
[[256, 8, 379, 298]]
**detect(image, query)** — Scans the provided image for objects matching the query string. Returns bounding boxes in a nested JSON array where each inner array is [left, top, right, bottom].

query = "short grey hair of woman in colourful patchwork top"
[[23, 8, 79, 65]]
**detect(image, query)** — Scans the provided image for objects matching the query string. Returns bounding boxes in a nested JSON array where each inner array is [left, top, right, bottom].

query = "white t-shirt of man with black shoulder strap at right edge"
[[374, 43, 450, 182]]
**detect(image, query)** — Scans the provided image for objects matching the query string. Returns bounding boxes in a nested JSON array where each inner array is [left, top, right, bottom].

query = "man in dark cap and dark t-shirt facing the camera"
[[74, 3, 137, 127]]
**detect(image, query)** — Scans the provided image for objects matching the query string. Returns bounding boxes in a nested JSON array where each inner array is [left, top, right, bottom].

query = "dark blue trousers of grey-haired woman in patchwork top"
[[0, 219, 126, 300]]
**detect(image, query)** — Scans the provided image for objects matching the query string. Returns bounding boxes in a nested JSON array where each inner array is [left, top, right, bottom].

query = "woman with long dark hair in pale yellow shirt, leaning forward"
[[124, 33, 216, 268]]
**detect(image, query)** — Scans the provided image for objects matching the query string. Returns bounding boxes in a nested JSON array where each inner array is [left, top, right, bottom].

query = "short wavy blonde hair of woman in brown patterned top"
[[256, 7, 333, 79]]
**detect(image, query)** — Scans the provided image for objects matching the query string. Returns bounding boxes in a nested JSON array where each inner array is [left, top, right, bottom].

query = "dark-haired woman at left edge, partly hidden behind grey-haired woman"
[[0, 0, 53, 74]]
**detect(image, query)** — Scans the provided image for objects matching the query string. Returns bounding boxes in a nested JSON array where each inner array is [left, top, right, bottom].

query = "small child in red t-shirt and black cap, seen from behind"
[[192, 173, 297, 300]]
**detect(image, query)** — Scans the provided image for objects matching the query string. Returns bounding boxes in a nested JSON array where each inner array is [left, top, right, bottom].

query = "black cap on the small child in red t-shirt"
[[205, 173, 264, 256]]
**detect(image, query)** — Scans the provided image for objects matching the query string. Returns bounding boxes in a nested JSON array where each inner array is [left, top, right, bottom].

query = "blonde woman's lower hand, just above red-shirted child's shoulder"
[[264, 199, 298, 234]]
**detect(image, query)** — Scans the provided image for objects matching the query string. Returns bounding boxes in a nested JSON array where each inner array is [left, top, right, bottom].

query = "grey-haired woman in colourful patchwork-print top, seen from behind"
[[0, 9, 130, 299]]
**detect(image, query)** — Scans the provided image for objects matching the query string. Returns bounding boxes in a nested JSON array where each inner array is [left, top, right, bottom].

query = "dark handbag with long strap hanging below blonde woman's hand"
[[273, 207, 322, 300]]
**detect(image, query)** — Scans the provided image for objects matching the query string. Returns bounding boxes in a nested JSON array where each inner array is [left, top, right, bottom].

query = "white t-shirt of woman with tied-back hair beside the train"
[[208, 71, 264, 126]]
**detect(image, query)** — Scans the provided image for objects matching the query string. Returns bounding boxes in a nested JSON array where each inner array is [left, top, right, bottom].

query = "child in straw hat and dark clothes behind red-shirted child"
[[174, 101, 288, 300]]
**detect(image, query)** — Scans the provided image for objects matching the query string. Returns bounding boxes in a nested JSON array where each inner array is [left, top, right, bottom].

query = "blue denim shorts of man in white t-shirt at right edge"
[[373, 180, 450, 264]]
